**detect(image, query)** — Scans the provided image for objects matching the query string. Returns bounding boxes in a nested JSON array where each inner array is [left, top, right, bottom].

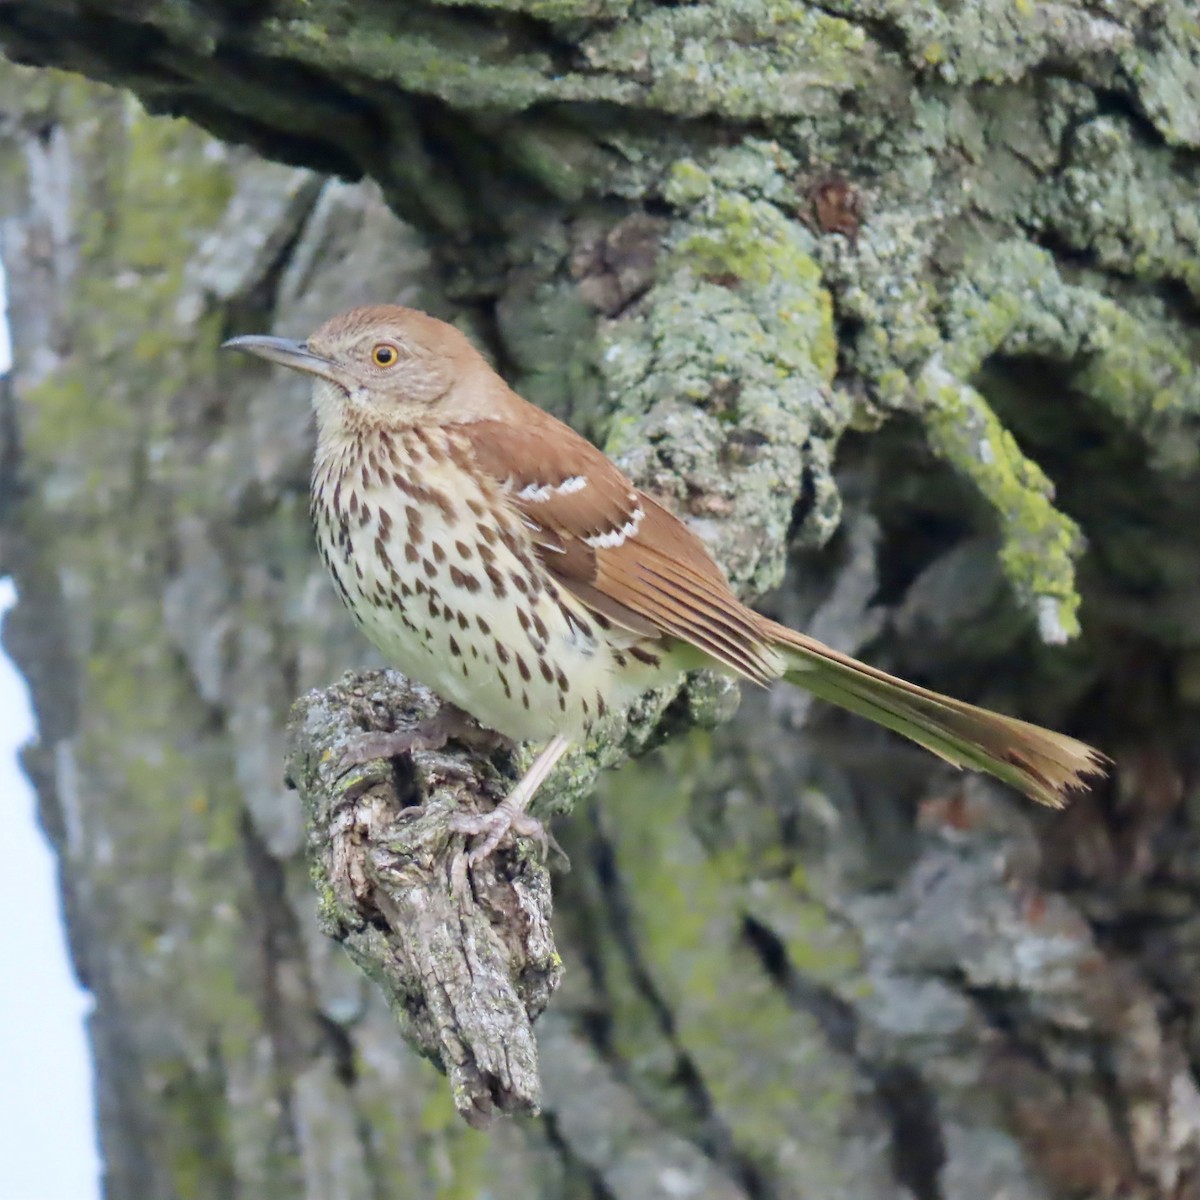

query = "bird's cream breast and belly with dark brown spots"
[[312, 427, 659, 739]]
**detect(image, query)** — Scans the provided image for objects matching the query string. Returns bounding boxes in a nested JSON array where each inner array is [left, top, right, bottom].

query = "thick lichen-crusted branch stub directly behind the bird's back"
[[600, 143, 848, 594]]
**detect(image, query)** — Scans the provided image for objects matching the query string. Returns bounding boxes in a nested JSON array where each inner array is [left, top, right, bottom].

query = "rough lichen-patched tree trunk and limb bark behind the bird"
[[0, 0, 1200, 1200]]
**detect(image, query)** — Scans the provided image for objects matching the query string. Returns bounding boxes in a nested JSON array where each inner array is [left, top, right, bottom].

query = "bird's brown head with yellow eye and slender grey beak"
[[224, 305, 498, 432]]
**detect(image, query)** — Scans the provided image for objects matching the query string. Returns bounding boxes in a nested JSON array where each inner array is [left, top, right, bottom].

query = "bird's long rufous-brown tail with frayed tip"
[[760, 617, 1109, 809]]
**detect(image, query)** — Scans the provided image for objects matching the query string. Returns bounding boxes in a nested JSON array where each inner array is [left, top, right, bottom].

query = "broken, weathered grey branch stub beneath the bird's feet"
[[287, 673, 563, 1128]]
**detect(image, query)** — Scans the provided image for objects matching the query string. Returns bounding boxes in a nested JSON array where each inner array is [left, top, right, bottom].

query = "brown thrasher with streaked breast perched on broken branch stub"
[[224, 306, 1105, 862]]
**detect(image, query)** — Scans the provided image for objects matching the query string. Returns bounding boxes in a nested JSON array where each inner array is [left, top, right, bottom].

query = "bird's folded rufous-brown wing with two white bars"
[[456, 415, 779, 683]]
